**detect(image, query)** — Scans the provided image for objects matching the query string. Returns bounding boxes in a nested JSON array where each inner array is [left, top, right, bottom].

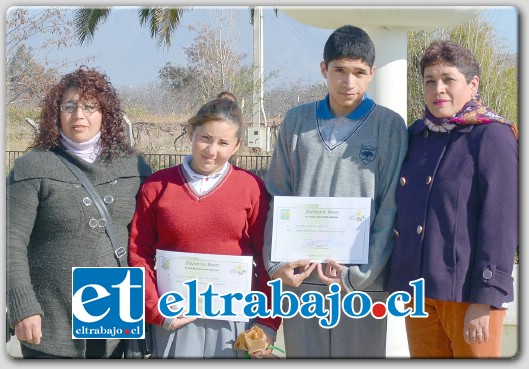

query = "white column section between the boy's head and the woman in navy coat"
[[364, 27, 408, 121]]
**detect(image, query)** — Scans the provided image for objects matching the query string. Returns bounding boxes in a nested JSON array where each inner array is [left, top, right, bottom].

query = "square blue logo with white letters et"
[[72, 267, 145, 339]]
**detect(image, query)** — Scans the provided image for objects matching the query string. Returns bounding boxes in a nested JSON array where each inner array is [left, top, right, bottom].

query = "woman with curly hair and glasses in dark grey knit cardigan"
[[7, 66, 151, 358]]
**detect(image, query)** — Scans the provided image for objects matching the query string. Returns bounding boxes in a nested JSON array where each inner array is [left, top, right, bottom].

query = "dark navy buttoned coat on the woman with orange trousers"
[[386, 120, 518, 308]]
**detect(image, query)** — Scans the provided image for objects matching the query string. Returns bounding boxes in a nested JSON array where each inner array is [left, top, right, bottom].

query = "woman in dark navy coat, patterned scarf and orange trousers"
[[387, 41, 518, 358]]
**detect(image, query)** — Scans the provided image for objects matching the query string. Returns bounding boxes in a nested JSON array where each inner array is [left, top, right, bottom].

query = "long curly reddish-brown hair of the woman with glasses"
[[32, 65, 132, 160]]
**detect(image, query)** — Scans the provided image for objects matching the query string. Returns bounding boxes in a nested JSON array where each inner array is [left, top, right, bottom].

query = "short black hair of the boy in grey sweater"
[[323, 25, 375, 68]]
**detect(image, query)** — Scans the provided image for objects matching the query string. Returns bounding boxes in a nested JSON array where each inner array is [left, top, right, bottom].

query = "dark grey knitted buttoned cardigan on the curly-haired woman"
[[7, 149, 151, 358]]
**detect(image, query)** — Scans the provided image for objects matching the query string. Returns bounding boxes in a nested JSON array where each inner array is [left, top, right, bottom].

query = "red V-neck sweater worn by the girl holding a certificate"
[[129, 165, 281, 330]]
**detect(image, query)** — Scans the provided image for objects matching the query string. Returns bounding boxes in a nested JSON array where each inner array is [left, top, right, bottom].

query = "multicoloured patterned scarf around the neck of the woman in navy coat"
[[424, 93, 518, 140]]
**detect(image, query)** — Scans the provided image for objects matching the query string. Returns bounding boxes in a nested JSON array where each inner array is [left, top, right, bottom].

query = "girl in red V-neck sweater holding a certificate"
[[129, 95, 281, 358]]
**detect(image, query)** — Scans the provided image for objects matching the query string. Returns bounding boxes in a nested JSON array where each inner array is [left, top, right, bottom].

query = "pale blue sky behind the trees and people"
[[10, 6, 518, 87]]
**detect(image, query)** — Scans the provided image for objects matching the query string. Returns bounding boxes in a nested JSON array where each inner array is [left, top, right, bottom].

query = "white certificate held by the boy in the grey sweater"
[[271, 196, 371, 264]]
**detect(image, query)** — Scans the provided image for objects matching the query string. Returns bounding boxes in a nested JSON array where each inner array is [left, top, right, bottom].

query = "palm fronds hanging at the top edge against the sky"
[[74, 6, 187, 49]]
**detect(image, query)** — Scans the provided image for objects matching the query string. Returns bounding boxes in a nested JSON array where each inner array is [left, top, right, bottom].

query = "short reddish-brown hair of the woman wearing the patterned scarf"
[[420, 40, 480, 83]]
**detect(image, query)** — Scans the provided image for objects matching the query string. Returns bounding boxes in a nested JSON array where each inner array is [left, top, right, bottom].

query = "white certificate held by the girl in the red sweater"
[[156, 250, 253, 322]]
